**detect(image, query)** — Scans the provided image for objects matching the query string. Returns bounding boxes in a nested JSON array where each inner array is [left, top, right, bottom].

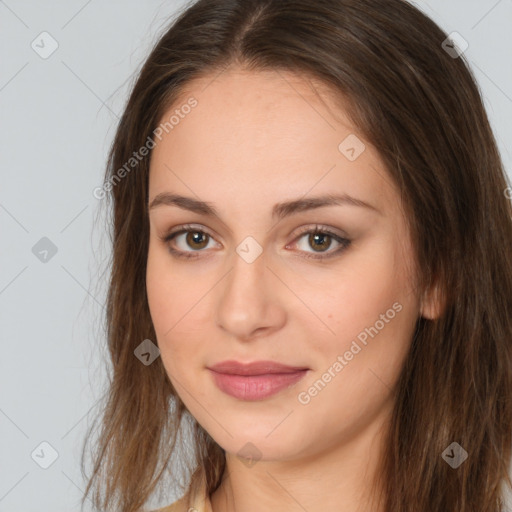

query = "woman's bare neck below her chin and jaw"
[[211, 404, 389, 512]]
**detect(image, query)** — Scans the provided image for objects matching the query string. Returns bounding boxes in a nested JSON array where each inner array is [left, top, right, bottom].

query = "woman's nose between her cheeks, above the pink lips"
[[216, 246, 286, 341]]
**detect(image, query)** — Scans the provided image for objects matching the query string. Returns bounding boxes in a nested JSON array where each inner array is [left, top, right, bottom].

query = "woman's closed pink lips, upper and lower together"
[[207, 361, 309, 400]]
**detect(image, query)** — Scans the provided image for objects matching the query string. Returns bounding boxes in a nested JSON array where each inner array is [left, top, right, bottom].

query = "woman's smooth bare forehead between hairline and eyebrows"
[[150, 69, 400, 216]]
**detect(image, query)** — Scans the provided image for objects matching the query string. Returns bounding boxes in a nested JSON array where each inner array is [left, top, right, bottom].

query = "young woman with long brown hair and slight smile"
[[80, 0, 512, 512]]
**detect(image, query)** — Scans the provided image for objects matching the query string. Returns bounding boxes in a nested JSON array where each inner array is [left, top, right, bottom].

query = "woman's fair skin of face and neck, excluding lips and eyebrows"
[[147, 68, 435, 512]]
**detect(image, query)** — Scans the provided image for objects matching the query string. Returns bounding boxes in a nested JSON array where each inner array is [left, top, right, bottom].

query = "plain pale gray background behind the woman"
[[0, 0, 512, 512]]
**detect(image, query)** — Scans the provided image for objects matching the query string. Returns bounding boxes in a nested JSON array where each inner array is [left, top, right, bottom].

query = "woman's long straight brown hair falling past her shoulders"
[[82, 0, 512, 512]]
